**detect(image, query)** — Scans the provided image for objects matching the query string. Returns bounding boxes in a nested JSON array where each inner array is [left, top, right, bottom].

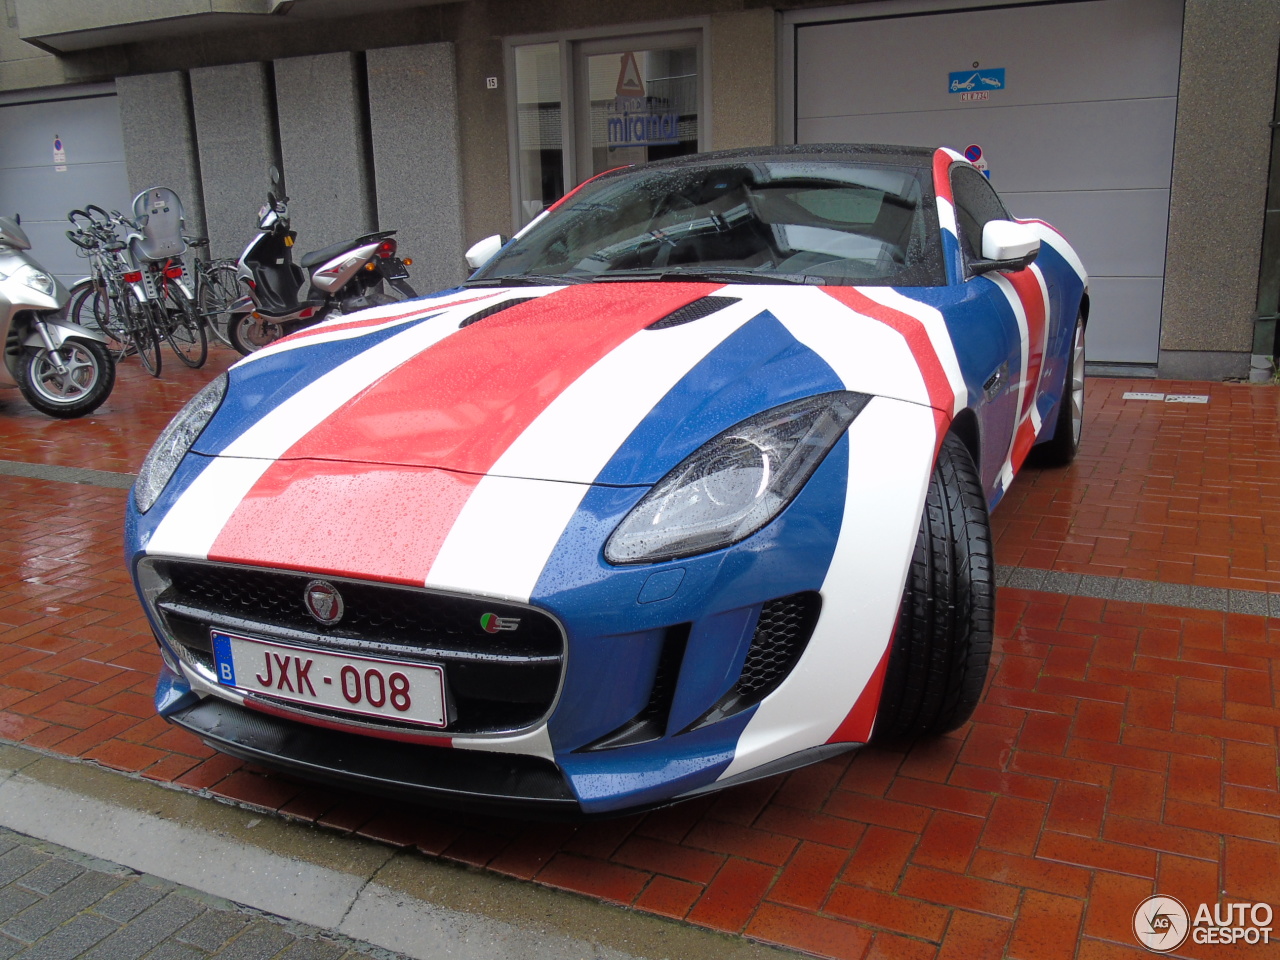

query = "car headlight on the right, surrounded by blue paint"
[[604, 392, 870, 563]]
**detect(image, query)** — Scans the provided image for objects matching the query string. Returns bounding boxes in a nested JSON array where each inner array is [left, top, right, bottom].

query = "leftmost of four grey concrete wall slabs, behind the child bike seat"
[[115, 70, 205, 236]]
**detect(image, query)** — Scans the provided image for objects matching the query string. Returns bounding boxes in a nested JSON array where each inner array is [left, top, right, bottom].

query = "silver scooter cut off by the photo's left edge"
[[0, 215, 115, 420]]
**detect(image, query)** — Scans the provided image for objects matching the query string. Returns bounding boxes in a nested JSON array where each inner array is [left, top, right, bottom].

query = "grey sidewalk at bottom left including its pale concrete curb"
[[0, 742, 797, 960]]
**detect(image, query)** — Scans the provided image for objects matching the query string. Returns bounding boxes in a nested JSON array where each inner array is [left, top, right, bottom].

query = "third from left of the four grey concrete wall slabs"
[[275, 52, 376, 251]]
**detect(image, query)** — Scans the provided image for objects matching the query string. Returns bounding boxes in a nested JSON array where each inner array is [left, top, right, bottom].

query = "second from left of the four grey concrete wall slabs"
[[191, 63, 279, 256]]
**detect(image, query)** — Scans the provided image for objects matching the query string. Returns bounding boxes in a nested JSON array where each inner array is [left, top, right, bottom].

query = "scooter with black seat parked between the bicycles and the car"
[[228, 166, 417, 356]]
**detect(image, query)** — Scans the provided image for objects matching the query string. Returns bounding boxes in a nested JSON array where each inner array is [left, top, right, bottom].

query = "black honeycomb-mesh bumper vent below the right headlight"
[[682, 590, 822, 733]]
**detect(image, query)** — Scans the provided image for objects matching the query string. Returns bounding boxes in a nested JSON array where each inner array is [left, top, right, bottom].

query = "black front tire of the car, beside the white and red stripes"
[[872, 435, 996, 742]]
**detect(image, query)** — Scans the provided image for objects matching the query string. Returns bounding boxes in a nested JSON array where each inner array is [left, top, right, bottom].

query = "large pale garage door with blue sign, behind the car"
[[792, 0, 1183, 364]]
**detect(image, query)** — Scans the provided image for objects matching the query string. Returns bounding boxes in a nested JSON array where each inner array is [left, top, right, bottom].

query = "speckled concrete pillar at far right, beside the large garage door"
[[1160, 0, 1280, 379]]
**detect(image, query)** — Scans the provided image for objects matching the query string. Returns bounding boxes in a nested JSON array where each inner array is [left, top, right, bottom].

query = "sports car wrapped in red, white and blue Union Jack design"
[[127, 145, 1089, 813]]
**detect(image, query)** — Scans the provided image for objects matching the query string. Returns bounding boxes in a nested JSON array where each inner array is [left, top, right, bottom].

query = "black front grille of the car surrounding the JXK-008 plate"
[[143, 558, 564, 735]]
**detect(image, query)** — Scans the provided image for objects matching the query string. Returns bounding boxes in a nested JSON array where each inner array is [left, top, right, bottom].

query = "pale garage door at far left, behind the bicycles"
[[0, 84, 132, 291]]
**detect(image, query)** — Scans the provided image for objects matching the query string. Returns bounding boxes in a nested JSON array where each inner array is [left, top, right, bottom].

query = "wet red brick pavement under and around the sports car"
[[0, 355, 1280, 960]]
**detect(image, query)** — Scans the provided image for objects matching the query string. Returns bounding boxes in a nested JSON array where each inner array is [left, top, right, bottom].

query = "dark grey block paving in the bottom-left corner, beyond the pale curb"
[[0, 828, 401, 960]]
